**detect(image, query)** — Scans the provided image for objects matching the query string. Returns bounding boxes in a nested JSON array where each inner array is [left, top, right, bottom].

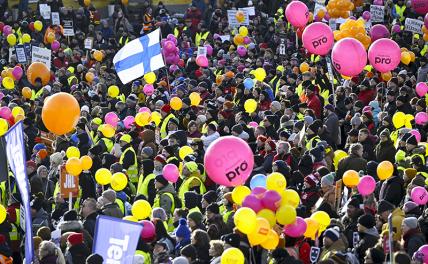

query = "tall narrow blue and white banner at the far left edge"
[[5, 122, 34, 264]]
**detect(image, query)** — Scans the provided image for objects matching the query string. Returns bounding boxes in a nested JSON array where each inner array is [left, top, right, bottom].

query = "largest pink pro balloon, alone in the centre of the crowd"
[[204, 136, 254, 186]]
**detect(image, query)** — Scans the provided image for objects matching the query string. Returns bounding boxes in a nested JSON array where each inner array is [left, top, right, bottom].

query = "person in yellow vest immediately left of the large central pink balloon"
[[178, 161, 206, 201]]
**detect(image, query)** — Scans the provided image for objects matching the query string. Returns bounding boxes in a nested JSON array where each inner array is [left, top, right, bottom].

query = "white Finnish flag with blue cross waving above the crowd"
[[113, 29, 165, 84]]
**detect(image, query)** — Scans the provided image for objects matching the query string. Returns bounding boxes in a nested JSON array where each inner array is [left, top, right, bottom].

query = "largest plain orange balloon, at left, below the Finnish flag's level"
[[42, 92, 80, 135]]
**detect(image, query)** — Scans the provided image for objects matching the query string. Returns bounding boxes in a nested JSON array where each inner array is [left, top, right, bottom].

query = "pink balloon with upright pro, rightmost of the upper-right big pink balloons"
[[369, 38, 401, 73]]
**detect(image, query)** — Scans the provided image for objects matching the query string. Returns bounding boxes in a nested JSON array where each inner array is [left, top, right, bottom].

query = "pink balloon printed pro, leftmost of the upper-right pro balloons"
[[302, 22, 334, 55]]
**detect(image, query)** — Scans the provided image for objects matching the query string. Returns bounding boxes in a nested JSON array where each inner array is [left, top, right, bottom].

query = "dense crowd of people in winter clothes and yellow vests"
[[0, 0, 428, 264]]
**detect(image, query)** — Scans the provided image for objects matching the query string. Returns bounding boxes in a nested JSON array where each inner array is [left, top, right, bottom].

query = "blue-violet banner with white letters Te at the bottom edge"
[[93, 215, 143, 264]]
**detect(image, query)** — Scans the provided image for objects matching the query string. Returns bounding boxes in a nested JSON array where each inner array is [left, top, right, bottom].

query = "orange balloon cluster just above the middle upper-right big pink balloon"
[[329, 19, 372, 49]]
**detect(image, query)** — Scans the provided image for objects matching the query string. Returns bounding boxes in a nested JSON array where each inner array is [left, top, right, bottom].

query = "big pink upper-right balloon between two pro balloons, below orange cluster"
[[331, 38, 367, 77]]
